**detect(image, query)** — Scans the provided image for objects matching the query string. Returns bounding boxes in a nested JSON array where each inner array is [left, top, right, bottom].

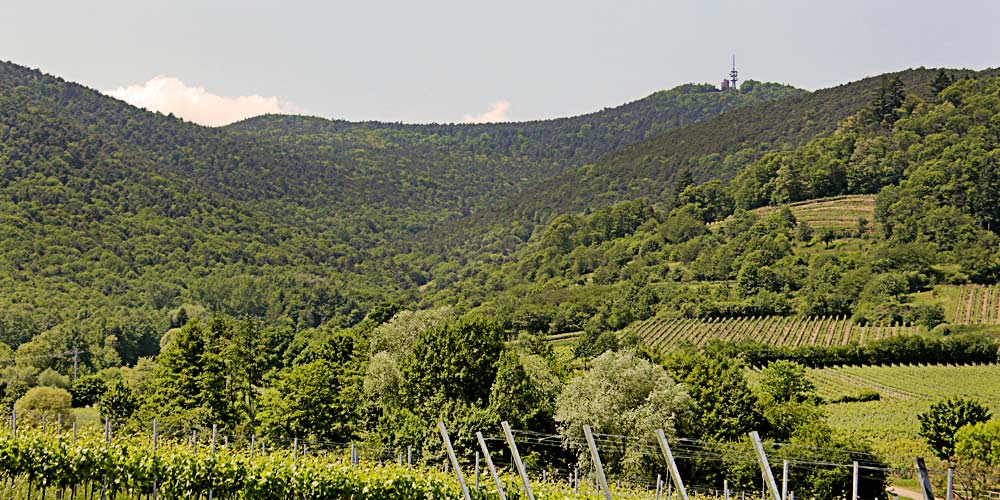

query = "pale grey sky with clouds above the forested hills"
[[0, 0, 1000, 125]]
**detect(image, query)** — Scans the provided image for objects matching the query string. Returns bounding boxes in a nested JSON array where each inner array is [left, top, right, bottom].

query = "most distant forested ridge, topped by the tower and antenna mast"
[[227, 80, 804, 168]]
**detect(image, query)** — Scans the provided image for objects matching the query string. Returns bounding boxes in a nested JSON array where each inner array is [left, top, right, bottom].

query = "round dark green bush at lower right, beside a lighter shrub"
[[917, 398, 990, 460]]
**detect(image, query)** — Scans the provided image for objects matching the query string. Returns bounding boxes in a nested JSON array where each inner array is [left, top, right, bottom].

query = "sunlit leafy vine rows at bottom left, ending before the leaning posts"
[[0, 433, 484, 500]]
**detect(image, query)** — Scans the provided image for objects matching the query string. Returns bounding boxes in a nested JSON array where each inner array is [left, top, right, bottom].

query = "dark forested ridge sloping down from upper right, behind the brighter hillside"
[[386, 68, 997, 271]]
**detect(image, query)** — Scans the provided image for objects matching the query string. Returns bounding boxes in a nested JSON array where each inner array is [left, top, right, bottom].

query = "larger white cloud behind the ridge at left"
[[104, 75, 302, 127]]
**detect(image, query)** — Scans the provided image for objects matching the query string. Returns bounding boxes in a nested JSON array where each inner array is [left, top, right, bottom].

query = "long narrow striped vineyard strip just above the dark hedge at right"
[[625, 316, 919, 349]]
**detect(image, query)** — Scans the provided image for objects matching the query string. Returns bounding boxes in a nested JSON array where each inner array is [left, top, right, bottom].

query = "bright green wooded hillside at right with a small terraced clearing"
[[423, 72, 1000, 344]]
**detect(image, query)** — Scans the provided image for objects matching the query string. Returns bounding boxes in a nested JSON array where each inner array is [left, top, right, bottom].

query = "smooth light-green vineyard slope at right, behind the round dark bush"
[[808, 365, 1000, 460]]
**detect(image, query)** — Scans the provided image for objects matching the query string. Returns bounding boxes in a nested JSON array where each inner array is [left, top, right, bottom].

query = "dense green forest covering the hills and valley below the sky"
[[0, 59, 1000, 497]]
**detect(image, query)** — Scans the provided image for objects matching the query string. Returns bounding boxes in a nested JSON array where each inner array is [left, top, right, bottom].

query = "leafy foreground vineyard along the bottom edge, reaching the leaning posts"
[[0, 416, 736, 500]]
